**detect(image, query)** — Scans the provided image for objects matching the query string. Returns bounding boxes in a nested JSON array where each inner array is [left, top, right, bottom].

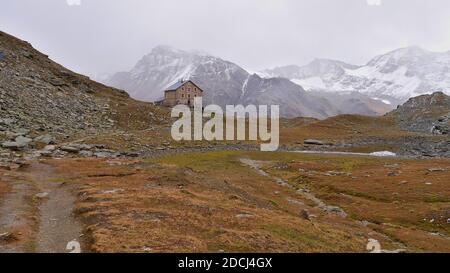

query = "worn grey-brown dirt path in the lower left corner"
[[0, 161, 83, 253]]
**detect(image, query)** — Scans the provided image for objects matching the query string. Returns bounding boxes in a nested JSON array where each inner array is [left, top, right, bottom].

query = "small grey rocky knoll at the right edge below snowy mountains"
[[388, 92, 450, 135]]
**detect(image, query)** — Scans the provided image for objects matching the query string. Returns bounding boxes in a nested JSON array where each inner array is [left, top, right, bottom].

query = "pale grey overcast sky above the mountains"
[[0, 0, 450, 76]]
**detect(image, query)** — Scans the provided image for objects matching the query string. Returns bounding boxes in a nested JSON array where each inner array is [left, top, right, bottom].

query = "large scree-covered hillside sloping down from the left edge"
[[0, 32, 164, 155]]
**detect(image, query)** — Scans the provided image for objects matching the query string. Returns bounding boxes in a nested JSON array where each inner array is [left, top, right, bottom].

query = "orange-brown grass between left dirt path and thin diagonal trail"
[[45, 153, 376, 252]]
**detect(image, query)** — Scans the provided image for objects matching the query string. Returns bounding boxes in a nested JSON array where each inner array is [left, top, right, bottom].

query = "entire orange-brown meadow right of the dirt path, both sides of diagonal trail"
[[26, 152, 450, 252]]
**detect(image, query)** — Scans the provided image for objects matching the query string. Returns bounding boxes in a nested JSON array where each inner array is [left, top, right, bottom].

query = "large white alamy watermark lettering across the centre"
[[171, 97, 280, 152]]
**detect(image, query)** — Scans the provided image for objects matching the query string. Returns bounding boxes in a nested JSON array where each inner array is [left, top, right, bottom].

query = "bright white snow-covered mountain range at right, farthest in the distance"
[[260, 47, 450, 105]]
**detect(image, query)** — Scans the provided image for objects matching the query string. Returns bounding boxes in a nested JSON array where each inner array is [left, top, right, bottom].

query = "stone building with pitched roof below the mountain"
[[163, 80, 203, 107]]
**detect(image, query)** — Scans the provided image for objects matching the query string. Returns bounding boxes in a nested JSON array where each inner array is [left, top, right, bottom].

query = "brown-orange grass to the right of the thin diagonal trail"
[[260, 153, 450, 252]]
